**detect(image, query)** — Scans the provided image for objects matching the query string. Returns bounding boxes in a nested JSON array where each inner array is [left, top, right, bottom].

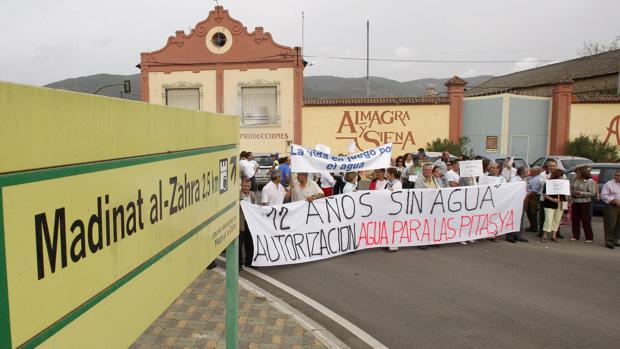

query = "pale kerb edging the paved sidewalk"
[[214, 267, 350, 349]]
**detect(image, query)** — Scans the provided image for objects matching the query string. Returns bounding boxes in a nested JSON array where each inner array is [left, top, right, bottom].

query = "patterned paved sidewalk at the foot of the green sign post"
[[130, 268, 326, 349]]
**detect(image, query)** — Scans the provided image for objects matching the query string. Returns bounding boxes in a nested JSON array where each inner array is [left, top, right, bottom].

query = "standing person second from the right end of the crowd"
[[570, 166, 596, 242]]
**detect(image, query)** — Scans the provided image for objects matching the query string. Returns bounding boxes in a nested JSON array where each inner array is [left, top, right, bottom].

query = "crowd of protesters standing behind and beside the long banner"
[[240, 148, 620, 266]]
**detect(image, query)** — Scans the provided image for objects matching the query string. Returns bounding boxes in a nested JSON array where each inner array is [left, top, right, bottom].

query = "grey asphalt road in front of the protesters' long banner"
[[241, 217, 620, 348]]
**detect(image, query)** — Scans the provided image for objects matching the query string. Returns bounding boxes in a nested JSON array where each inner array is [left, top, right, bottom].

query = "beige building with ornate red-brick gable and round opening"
[[139, 6, 304, 152]]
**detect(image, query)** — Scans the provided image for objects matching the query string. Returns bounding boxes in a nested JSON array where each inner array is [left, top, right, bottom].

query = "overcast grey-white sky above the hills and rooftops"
[[0, 0, 620, 85]]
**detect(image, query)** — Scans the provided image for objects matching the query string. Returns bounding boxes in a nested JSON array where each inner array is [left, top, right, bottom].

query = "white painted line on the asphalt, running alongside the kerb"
[[217, 256, 388, 349]]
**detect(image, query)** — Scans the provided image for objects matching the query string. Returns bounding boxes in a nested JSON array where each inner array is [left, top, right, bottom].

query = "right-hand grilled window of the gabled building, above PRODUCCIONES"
[[241, 86, 280, 126]]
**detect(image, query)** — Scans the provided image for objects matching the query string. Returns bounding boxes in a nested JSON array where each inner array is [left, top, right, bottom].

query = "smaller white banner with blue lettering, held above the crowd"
[[291, 143, 392, 173]]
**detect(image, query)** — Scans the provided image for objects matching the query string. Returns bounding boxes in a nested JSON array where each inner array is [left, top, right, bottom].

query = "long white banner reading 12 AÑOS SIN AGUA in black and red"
[[241, 182, 525, 266]]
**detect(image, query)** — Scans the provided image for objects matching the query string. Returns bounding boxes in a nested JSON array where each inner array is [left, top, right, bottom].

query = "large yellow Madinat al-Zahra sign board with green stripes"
[[0, 84, 239, 348]]
